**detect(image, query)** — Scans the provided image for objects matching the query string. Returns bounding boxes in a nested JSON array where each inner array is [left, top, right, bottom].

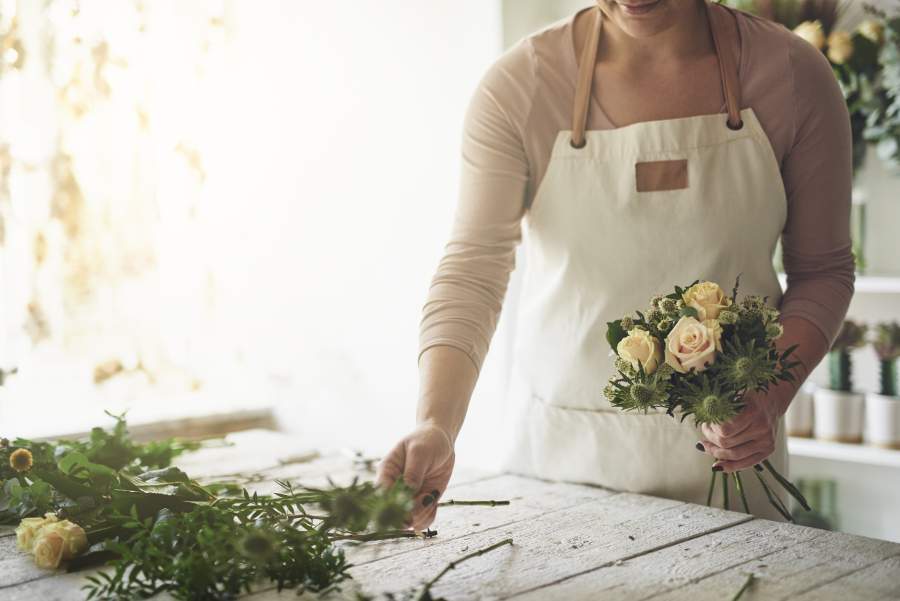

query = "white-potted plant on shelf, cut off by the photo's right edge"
[[866, 321, 900, 449]]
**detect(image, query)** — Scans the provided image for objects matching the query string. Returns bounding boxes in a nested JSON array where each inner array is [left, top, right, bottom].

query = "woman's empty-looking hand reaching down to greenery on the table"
[[375, 423, 456, 530]]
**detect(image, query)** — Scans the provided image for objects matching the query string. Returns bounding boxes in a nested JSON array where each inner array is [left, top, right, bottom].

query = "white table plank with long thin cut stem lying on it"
[[351, 485, 752, 599]]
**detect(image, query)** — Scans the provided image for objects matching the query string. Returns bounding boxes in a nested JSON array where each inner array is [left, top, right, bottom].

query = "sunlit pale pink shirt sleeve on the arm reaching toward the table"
[[418, 41, 534, 373]]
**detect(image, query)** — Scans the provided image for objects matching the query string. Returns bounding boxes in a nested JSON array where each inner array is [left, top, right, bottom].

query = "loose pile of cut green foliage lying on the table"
[[0, 417, 414, 600]]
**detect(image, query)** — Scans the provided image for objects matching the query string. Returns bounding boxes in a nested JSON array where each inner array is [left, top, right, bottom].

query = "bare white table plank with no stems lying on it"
[[506, 520, 823, 601]]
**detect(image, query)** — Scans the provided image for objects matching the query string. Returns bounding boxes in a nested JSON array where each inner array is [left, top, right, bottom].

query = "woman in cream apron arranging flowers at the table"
[[378, 0, 854, 529]]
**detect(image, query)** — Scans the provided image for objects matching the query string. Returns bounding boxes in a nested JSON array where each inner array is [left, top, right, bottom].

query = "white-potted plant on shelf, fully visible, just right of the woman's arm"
[[813, 319, 866, 443]]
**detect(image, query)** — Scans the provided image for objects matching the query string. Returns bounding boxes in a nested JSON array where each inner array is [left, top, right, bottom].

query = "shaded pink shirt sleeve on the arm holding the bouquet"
[[781, 36, 855, 348]]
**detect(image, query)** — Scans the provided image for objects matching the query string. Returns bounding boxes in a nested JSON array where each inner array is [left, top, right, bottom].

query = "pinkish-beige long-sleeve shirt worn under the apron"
[[419, 5, 854, 371]]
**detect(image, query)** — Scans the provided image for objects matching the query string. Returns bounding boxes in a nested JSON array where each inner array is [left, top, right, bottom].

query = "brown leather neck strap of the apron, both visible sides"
[[570, 0, 744, 148]]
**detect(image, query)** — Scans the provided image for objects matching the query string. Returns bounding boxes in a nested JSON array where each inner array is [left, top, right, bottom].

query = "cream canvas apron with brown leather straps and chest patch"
[[505, 0, 787, 520]]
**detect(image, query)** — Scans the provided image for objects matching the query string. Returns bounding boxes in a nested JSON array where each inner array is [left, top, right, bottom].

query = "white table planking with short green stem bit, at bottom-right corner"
[[652, 531, 900, 601]]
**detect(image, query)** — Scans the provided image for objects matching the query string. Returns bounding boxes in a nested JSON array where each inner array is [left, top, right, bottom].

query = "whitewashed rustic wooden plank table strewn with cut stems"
[[0, 431, 900, 601]]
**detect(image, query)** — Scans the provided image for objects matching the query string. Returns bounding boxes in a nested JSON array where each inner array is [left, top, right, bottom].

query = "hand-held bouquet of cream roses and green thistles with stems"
[[604, 278, 809, 521]]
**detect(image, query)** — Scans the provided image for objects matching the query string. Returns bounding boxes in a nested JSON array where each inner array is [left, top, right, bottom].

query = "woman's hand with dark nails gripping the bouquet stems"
[[697, 387, 780, 473]]
